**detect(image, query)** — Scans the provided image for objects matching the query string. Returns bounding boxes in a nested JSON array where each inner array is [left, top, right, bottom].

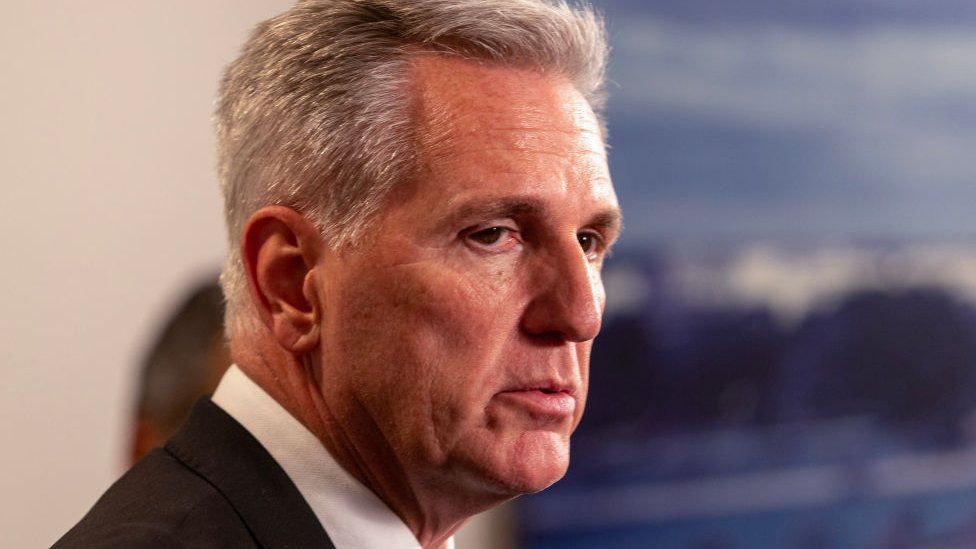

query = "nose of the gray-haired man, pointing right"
[[522, 242, 604, 342]]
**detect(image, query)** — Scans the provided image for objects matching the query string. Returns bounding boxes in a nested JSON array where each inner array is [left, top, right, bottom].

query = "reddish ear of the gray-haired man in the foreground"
[[241, 206, 323, 355]]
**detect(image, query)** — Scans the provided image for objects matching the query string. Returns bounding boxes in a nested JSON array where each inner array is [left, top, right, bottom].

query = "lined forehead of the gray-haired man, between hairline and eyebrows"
[[411, 55, 616, 210]]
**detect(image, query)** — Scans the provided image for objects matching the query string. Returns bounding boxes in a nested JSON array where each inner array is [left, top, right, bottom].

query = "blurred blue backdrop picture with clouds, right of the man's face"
[[519, 0, 976, 549]]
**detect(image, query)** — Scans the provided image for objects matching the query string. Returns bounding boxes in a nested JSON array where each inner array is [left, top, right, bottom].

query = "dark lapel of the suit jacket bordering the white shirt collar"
[[166, 398, 334, 549]]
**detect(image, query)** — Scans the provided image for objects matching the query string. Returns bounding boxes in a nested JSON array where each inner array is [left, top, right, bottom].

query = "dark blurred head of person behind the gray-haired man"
[[130, 280, 231, 463]]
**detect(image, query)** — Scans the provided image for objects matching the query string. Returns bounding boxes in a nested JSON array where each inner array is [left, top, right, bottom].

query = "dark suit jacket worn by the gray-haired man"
[[54, 399, 333, 549]]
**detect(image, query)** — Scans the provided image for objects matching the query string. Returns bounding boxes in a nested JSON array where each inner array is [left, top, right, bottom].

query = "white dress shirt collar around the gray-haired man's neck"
[[213, 366, 454, 549]]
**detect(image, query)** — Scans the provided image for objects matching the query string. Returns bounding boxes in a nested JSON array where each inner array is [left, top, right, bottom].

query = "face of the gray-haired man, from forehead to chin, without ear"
[[320, 56, 619, 495]]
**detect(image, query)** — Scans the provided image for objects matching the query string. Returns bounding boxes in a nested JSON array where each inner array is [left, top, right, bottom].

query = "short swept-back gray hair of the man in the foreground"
[[216, 0, 607, 335]]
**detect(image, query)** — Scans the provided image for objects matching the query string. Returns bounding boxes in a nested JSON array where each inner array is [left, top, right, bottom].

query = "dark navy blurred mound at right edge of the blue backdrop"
[[782, 288, 976, 444]]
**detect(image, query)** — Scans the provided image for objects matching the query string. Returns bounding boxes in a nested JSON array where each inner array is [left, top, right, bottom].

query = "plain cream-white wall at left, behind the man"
[[0, 0, 516, 548]]
